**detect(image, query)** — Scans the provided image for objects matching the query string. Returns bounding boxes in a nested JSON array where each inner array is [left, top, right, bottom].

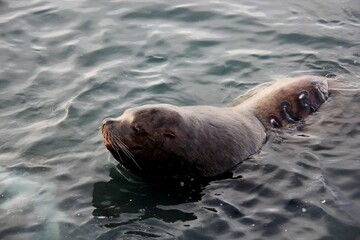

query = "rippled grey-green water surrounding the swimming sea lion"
[[0, 0, 360, 240]]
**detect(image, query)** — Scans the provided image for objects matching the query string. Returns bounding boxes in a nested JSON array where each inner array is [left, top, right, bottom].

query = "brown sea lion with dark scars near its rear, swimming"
[[101, 76, 328, 177]]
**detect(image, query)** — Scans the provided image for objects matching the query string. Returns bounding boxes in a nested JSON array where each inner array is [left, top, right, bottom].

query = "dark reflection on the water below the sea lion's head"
[[93, 166, 204, 224]]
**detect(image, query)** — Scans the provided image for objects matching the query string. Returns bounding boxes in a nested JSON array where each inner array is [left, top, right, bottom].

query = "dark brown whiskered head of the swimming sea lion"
[[101, 104, 184, 175]]
